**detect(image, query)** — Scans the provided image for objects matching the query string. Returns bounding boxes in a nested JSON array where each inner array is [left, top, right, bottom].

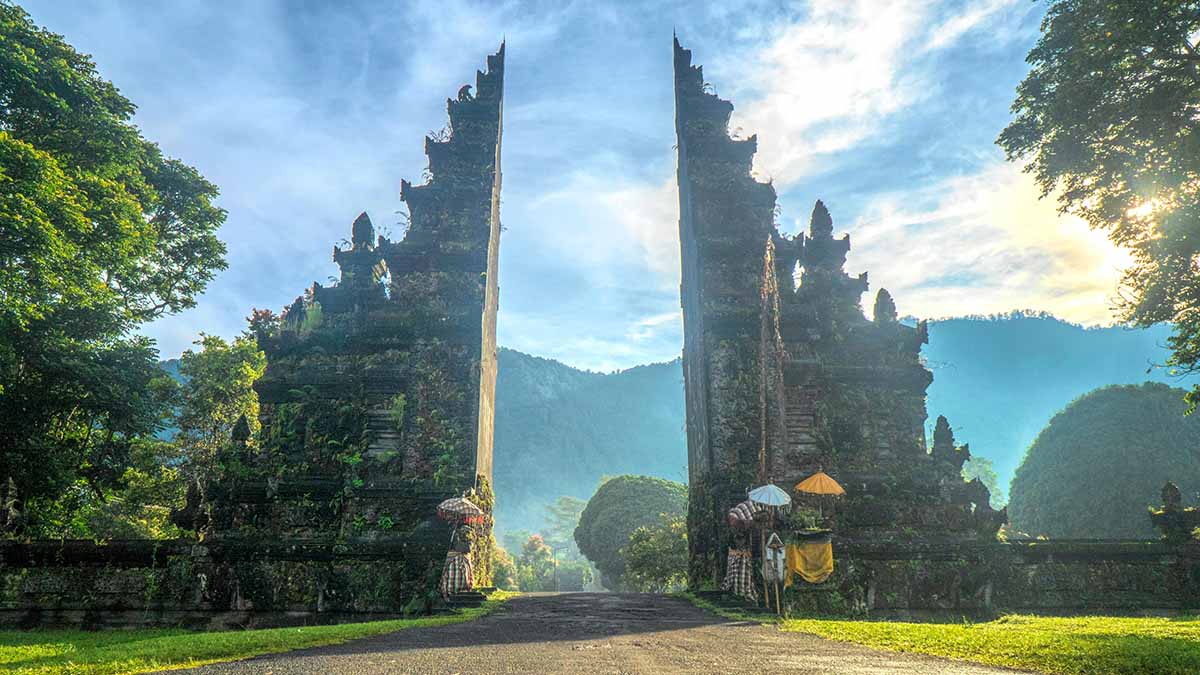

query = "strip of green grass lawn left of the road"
[[0, 591, 508, 675]]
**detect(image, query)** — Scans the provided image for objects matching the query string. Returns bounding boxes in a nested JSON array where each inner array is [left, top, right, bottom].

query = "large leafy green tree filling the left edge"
[[0, 0, 226, 528]]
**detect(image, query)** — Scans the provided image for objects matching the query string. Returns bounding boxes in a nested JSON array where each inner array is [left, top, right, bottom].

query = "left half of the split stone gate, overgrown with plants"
[[172, 44, 504, 620]]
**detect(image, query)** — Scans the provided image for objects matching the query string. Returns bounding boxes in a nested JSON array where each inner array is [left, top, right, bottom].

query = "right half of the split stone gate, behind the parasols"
[[674, 40, 1006, 587]]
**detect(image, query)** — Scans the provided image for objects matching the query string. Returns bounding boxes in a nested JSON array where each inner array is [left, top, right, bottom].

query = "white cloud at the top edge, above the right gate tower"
[[713, 0, 1018, 185]]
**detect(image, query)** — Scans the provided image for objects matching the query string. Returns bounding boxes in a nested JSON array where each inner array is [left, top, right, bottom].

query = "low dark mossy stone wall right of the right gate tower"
[[784, 539, 1200, 619]]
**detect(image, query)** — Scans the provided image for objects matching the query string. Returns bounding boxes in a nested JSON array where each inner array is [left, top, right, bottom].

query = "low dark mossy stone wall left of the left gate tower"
[[0, 532, 445, 629]]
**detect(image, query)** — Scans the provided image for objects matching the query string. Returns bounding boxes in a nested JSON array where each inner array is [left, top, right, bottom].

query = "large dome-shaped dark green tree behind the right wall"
[[1008, 383, 1200, 538]]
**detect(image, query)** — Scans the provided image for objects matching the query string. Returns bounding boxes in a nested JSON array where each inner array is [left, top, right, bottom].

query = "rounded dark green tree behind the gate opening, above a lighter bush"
[[575, 476, 688, 590]]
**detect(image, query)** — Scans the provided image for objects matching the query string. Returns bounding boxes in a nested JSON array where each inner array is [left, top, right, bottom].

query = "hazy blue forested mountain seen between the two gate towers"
[[493, 348, 688, 531]]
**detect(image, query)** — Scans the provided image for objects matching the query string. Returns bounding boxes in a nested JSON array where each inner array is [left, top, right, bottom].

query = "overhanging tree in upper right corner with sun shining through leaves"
[[997, 0, 1200, 408]]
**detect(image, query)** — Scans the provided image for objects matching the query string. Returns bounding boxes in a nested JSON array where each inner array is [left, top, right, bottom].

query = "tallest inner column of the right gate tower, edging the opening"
[[674, 40, 775, 580]]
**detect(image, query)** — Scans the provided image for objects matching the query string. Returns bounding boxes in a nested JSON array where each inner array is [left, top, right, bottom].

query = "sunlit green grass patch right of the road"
[[780, 615, 1200, 675]]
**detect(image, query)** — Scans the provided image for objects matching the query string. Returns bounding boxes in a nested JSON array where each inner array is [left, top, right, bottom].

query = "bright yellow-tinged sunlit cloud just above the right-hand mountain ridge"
[[847, 163, 1129, 324]]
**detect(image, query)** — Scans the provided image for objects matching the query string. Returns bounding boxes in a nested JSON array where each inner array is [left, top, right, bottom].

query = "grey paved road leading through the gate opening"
[[176, 593, 1027, 675]]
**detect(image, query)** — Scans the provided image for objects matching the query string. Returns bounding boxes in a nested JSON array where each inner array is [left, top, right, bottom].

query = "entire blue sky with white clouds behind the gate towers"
[[23, 0, 1128, 371]]
